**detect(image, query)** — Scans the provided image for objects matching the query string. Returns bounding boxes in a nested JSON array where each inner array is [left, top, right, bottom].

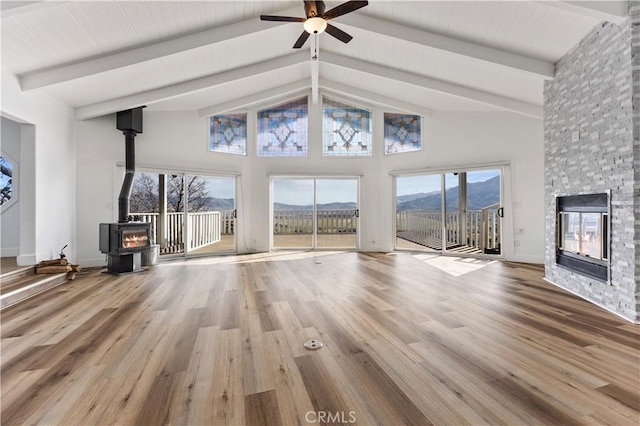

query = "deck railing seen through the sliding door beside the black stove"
[[132, 210, 235, 254]]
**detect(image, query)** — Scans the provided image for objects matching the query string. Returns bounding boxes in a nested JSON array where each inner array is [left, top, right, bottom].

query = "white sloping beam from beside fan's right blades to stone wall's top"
[[340, 13, 555, 79]]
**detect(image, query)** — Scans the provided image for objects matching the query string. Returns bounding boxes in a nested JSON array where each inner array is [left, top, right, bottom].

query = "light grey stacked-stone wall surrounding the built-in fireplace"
[[544, 2, 640, 321]]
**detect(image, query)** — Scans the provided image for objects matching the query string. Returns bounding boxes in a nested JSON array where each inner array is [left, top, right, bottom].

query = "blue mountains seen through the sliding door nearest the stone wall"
[[396, 176, 500, 211]]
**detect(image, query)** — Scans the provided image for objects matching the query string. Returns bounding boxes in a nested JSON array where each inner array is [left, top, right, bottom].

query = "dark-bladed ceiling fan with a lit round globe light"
[[260, 1, 369, 49]]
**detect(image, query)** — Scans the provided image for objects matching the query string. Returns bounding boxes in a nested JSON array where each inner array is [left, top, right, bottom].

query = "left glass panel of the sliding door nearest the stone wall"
[[396, 174, 443, 251]]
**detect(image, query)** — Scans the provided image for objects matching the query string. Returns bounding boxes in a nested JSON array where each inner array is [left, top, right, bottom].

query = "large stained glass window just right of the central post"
[[322, 98, 373, 157]]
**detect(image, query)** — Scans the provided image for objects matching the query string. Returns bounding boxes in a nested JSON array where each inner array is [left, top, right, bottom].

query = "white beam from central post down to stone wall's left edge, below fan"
[[322, 52, 542, 119]]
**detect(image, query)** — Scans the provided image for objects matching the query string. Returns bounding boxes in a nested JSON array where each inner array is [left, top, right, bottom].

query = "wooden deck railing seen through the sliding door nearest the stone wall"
[[396, 204, 500, 252]]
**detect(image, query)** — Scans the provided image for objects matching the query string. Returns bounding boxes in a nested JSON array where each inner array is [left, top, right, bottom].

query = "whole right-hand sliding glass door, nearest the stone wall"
[[395, 168, 502, 255]]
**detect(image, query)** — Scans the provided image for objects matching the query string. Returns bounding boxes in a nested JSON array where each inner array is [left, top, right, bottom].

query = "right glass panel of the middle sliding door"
[[315, 179, 360, 248]]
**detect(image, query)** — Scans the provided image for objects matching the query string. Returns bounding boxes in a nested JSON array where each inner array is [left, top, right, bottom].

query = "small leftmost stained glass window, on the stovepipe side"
[[209, 114, 247, 155]]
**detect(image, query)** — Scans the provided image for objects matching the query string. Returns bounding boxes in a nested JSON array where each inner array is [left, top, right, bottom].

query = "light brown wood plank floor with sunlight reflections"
[[1, 252, 640, 426]]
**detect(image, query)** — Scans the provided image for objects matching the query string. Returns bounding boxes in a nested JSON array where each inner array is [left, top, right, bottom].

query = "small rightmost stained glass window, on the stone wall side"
[[384, 112, 422, 154]]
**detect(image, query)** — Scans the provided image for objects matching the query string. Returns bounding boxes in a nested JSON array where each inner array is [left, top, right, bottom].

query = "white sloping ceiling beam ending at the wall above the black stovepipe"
[[75, 52, 309, 120]]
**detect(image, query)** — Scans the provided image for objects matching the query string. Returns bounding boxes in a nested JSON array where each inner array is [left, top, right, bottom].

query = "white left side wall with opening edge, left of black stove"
[[0, 69, 77, 264]]
